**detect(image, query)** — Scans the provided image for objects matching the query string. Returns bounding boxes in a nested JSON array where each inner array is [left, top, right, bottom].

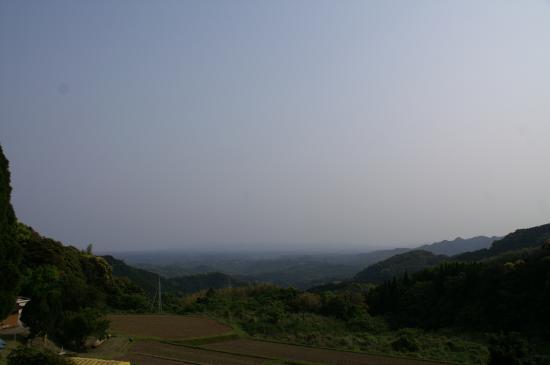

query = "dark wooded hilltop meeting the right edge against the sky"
[[453, 224, 550, 261]]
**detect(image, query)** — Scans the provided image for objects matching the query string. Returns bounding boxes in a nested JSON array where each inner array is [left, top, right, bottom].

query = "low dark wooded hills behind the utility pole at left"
[[103, 255, 244, 296]]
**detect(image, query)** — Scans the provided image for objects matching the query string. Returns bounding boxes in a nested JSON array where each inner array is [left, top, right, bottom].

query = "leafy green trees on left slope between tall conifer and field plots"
[[17, 223, 147, 349]]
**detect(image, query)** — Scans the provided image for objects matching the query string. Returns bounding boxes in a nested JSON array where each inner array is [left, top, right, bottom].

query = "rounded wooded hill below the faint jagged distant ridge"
[[353, 250, 448, 283]]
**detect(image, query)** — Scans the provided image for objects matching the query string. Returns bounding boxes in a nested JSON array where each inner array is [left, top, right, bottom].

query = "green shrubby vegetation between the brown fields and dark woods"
[[175, 285, 488, 364]]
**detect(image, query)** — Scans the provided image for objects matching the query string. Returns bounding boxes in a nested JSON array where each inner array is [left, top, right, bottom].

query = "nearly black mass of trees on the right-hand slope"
[[368, 249, 550, 334]]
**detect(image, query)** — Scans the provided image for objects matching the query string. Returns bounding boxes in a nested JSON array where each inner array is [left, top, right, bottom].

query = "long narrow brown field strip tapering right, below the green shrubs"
[[204, 339, 443, 365]]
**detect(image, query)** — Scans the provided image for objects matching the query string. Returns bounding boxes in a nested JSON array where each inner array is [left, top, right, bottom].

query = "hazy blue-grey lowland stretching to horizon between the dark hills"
[[126, 249, 388, 289]]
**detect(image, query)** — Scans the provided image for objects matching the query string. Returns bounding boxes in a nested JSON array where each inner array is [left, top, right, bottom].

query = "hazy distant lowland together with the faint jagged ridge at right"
[[108, 236, 498, 289]]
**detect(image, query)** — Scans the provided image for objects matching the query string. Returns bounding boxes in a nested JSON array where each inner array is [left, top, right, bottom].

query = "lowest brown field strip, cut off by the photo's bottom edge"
[[129, 341, 268, 365]]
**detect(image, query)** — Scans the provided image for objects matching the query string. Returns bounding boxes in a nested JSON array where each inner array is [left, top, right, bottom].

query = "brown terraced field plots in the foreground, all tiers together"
[[96, 315, 452, 365]]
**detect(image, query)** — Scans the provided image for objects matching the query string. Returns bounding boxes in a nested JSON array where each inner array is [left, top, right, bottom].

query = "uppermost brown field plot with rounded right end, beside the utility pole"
[[109, 315, 231, 340]]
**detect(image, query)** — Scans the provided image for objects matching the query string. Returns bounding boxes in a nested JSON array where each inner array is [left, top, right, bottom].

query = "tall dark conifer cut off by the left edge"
[[0, 146, 21, 318]]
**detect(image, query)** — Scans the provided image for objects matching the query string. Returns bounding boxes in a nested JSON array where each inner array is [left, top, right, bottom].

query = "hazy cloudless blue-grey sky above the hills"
[[0, 0, 550, 251]]
